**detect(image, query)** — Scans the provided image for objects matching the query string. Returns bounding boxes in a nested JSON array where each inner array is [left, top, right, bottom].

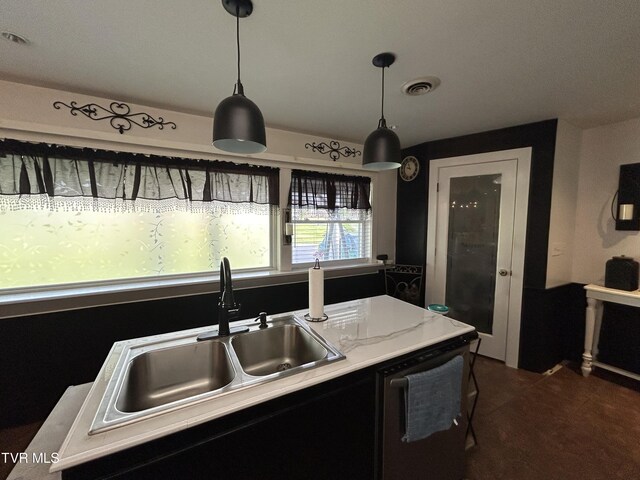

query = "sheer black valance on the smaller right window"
[[289, 170, 371, 211]]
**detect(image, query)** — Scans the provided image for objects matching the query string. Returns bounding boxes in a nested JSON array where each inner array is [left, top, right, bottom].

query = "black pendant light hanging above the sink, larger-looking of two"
[[213, 0, 267, 154]]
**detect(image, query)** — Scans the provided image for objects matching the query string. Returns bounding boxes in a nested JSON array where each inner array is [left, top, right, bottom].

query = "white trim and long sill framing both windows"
[[0, 152, 383, 319]]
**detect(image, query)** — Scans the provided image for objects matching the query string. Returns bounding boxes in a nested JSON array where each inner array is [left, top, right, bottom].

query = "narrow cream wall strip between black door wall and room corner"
[[546, 120, 582, 288]]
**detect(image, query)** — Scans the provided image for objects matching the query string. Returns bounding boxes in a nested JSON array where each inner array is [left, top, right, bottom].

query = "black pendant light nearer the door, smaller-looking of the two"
[[362, 53, 401, 170]]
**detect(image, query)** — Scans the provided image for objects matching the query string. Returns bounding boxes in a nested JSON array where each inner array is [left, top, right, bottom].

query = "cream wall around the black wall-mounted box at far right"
[[568, 118, 640, 285]]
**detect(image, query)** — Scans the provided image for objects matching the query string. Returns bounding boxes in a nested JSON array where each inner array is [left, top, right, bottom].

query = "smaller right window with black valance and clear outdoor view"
[[289, 170, 371, 264]]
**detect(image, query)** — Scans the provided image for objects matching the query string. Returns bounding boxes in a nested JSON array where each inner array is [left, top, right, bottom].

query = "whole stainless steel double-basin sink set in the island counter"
[[89, 315, 345, 434]]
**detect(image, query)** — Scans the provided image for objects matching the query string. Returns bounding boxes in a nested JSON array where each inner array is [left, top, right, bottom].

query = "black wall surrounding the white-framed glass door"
[[396, 120, 563, 372]]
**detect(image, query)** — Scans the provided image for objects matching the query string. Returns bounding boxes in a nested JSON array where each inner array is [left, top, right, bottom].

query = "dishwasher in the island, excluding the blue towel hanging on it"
[[375, 331, 478, 480]]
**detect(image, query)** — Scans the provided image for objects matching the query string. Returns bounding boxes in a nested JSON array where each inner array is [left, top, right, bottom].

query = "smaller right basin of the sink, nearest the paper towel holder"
[[231, 325, 327, 376]]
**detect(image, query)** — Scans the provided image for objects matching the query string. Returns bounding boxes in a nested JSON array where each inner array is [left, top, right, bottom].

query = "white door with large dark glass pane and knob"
[[427, 159, 518, 361]]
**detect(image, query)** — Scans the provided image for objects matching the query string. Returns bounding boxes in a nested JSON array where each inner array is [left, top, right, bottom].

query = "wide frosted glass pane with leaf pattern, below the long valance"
[[0, 205, 271, 288]]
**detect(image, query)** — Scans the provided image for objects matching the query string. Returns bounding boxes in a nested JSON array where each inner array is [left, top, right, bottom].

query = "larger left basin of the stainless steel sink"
[[116, 341, 235, 412]]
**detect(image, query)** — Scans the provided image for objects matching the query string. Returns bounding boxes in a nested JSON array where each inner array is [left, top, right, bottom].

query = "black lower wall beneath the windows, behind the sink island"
[[0, 273, 385, 428]]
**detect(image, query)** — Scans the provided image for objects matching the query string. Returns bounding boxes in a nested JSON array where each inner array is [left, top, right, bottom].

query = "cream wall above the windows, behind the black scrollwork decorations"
[[0, 80, 397, 259]]
